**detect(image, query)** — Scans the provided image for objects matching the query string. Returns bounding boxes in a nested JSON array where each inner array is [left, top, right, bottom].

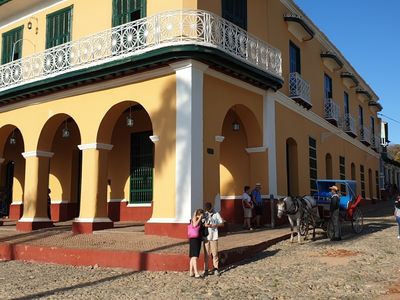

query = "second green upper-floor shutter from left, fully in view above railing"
[[46, 6, 72, 49]]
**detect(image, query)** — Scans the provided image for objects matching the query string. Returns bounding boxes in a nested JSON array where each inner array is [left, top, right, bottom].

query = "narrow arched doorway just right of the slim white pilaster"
[[286, 138, 299, 196]]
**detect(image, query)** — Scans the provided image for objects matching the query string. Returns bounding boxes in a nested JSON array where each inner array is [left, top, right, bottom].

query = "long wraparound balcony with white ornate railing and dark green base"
[[0, 10, 283, 99]]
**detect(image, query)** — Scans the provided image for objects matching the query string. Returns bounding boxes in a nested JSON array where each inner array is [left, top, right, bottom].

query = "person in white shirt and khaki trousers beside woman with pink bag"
[[204, 202, 224, 276]]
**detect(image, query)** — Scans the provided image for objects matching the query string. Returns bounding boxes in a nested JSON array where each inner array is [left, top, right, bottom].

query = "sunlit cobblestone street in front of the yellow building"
[[0, 200, 400, 299]]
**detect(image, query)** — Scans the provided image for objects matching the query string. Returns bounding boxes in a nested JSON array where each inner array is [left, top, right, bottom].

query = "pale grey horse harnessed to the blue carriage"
[[277, 196, 320, 243]]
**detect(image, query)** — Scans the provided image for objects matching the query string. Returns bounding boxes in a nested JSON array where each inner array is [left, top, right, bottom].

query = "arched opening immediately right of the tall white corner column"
[[217, 104, 265, 195]]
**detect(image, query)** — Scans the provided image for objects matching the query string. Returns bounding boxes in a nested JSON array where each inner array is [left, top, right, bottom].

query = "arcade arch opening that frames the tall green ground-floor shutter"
[[101, 100, 155, 213]]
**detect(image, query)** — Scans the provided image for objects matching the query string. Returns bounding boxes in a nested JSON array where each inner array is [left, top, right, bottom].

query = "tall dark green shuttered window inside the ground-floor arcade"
[[130, 131, 154, 203]]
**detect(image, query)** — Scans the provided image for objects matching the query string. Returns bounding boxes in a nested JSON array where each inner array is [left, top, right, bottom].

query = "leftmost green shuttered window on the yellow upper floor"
[[1, 26, 24, 64]]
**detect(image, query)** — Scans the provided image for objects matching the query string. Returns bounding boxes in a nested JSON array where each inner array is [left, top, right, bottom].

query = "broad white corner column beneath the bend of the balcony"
[[171, 60, 207, 223]]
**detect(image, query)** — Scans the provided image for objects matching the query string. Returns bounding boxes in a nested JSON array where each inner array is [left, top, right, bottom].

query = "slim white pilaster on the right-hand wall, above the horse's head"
[[263, 91, 278, 196]]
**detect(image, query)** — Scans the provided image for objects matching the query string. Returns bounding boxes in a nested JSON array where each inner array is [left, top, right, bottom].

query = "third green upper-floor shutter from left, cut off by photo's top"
[[112, 0, 146, 27]]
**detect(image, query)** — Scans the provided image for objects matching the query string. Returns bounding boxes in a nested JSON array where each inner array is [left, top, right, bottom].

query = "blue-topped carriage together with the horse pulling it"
[[278, 179, 363, 241]]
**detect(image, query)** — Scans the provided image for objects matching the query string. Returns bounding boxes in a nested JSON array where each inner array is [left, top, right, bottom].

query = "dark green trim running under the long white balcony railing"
[[0, 45, 283, 104]]
